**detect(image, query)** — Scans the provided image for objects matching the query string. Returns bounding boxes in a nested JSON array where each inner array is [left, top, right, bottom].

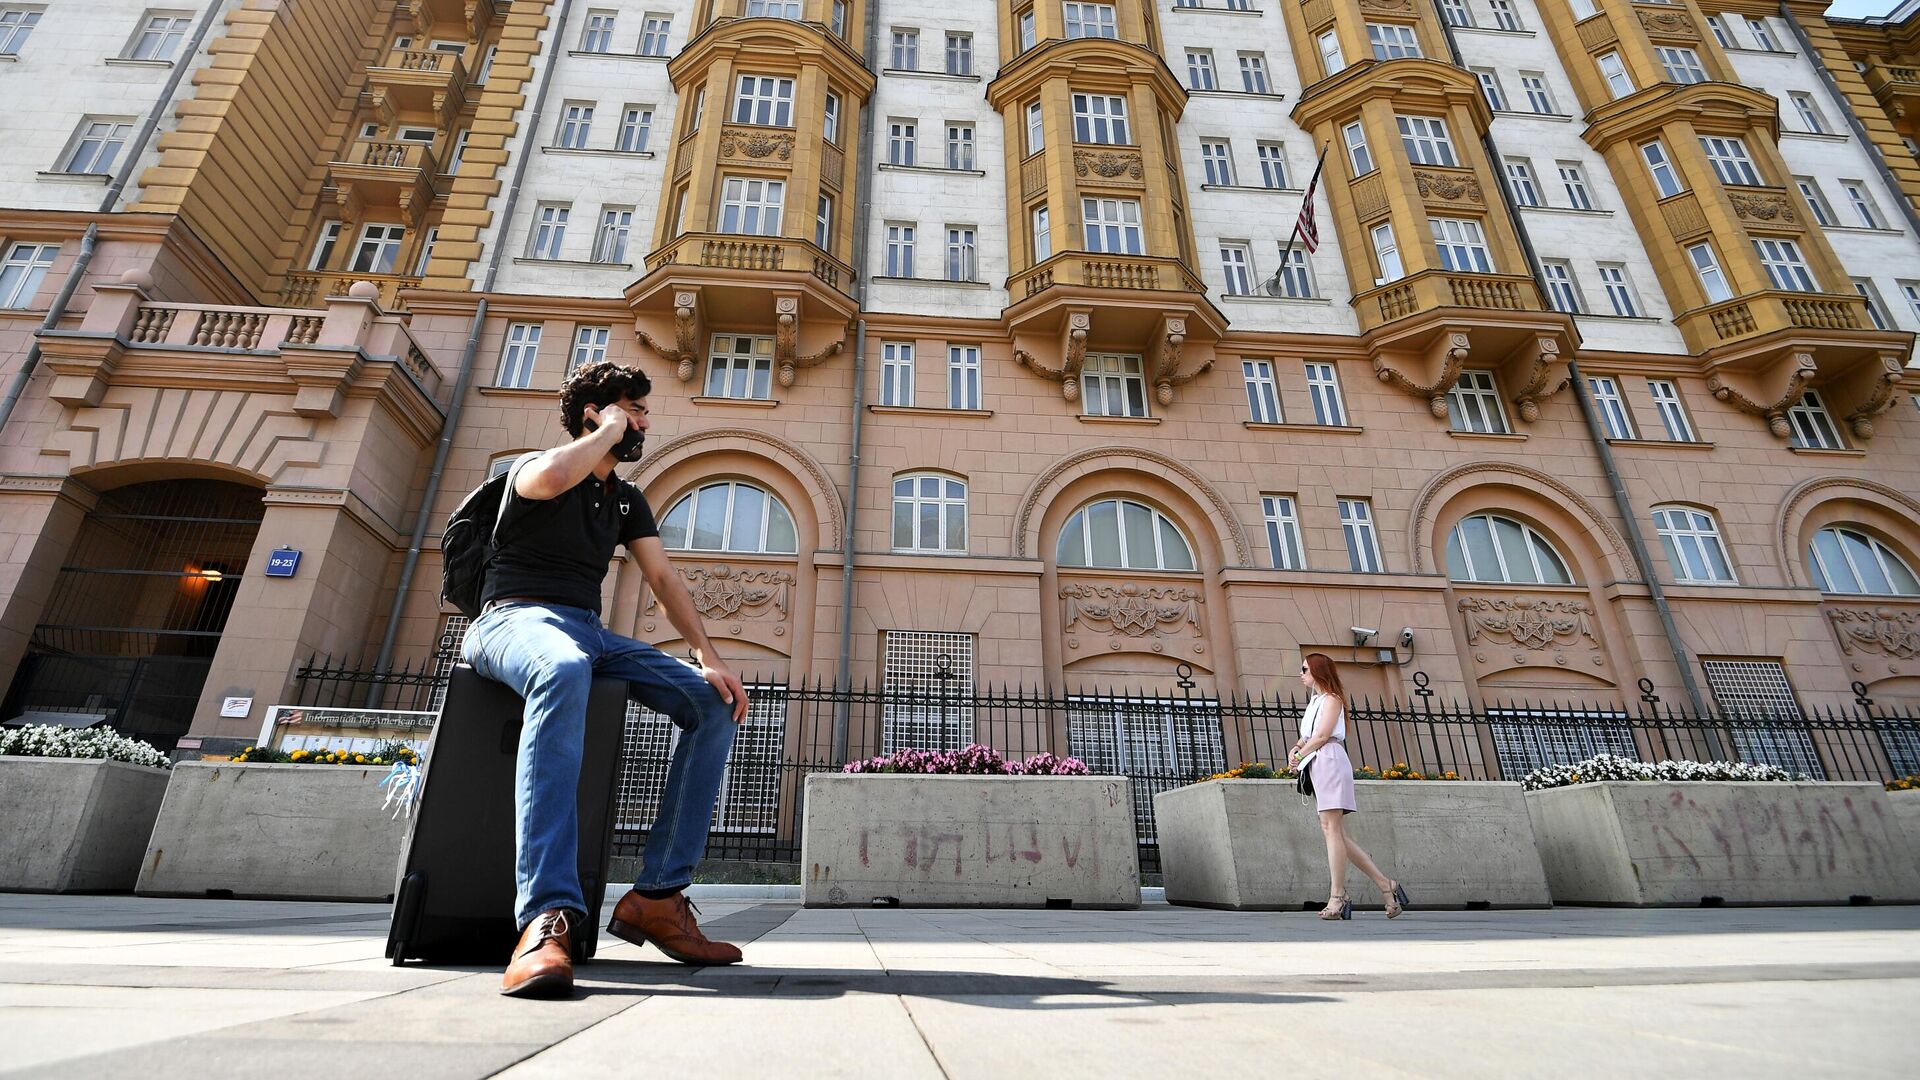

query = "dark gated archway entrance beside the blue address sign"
[[0, 480, 265, 749]]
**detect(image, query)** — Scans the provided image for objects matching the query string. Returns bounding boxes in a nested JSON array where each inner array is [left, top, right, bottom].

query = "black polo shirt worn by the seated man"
[[480, 459, 660, 615]]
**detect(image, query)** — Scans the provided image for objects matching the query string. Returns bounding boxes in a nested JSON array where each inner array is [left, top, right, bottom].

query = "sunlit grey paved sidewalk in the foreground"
[[0, 896, 1920, 1080]]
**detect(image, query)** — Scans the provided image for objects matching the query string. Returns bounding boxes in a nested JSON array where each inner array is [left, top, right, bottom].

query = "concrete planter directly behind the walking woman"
[[1154, 780, 1549, 911]]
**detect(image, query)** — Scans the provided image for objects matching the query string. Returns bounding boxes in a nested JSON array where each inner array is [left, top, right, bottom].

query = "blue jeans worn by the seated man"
[[465, 603, 733, 928]]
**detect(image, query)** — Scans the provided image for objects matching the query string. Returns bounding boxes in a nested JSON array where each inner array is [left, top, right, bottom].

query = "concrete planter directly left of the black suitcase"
[[134, 761, 407, 899]]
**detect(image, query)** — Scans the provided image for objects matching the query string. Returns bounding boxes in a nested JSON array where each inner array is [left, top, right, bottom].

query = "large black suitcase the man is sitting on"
[[386, 663, 626, 965]]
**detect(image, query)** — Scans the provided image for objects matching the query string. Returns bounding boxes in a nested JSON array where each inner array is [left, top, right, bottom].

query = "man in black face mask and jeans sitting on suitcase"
[[465, 363, 747, 997]]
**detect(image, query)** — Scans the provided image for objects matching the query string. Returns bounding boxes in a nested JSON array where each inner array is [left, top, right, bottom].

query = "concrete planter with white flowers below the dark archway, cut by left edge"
[[0, 757, 167, 892]]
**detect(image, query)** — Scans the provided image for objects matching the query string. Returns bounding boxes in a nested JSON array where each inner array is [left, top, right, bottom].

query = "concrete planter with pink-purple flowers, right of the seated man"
[[801, 773, 1140, 907]]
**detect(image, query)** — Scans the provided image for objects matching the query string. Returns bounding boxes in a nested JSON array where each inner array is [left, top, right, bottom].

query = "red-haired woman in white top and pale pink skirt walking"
[[1286, 653, 1407, 919]]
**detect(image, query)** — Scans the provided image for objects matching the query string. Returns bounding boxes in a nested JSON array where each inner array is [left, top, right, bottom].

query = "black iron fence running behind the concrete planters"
[[298, 661, 1920, 871]]
